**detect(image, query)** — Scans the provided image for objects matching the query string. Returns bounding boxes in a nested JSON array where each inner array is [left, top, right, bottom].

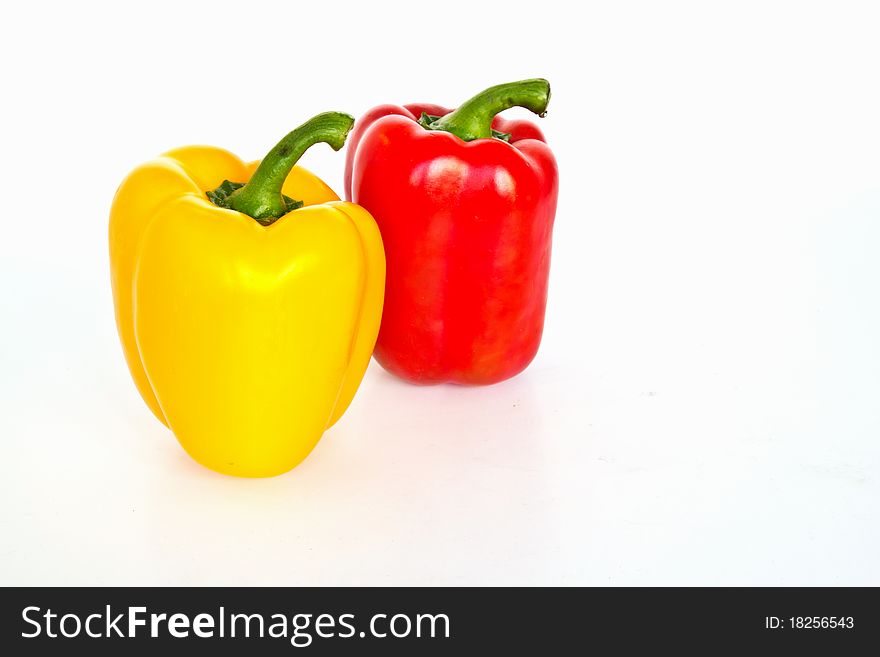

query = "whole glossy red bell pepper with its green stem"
[[345, 80, 558, 384]]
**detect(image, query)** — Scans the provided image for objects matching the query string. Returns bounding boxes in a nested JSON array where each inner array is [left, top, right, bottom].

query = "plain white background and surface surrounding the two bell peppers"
[[0, 0, 880, 585]]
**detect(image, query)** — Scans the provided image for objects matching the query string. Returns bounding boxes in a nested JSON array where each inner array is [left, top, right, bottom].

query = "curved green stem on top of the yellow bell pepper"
[[223, 112, 354, 225]]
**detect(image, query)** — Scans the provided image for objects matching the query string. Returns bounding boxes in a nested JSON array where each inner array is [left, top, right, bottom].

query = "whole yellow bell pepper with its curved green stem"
[[109, 112, 385, 477]]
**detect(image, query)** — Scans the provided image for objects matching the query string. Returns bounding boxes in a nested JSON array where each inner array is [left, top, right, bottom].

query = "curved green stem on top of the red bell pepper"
[[422, 78, 550, 141]]
